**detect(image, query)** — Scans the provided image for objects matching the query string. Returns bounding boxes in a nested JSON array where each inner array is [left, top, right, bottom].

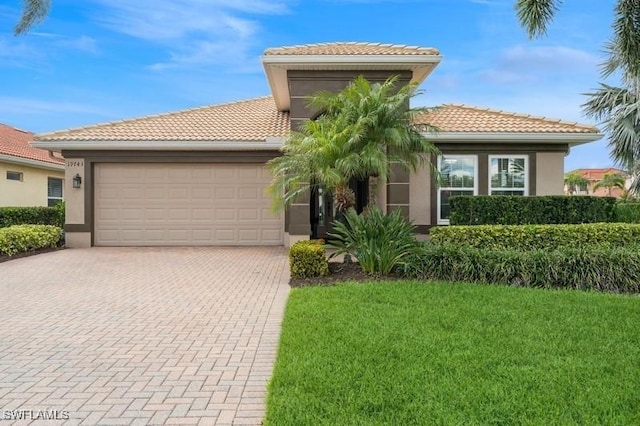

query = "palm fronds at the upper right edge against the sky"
[[516, 0, 640, 194]]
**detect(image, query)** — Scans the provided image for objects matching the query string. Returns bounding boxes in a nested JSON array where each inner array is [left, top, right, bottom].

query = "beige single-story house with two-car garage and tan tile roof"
[[34, 43, 602, 247]]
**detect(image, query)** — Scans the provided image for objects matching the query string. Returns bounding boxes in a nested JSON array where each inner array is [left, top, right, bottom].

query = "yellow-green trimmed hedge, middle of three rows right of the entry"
[[430, 223, 640, 250]]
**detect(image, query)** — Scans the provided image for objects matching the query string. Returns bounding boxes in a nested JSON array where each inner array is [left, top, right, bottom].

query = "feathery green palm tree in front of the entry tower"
[[268, 77, 438, 210]]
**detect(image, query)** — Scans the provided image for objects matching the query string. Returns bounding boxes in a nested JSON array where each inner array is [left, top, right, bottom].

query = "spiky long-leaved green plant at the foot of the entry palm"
[[328, 207, 416, 275]]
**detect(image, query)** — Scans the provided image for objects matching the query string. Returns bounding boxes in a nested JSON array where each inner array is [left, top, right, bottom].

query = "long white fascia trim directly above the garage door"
[[31, 137, 284, 151]]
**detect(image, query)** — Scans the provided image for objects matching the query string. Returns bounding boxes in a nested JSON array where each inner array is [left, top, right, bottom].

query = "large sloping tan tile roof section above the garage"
[[36, 96, 290, 141]]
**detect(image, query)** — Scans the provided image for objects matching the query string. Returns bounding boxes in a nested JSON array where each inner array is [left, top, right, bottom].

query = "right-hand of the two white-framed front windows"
[[489, 155, 529, 195]]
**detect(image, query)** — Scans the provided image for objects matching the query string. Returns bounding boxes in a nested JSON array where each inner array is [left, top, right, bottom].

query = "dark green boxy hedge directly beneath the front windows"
[[450, 195, 616, 225]]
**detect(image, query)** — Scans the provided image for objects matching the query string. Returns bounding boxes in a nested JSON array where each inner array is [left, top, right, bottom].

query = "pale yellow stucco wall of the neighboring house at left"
[[0, 162, 66, 207]]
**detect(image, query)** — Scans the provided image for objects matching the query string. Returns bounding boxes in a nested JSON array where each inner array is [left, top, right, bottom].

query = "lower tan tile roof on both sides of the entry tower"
[[36, 97, 598, 142]]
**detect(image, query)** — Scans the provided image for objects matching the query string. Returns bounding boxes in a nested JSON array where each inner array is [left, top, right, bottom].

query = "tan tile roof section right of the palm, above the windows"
[[415, 104, 598, 133]]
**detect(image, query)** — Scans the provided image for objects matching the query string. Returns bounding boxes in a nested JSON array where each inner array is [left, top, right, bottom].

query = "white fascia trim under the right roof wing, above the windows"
[[422, 132, 604, 145]]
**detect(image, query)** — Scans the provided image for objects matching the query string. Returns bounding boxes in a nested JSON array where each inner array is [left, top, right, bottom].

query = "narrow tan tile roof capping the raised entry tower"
[[264, 42, 440, 56]]
